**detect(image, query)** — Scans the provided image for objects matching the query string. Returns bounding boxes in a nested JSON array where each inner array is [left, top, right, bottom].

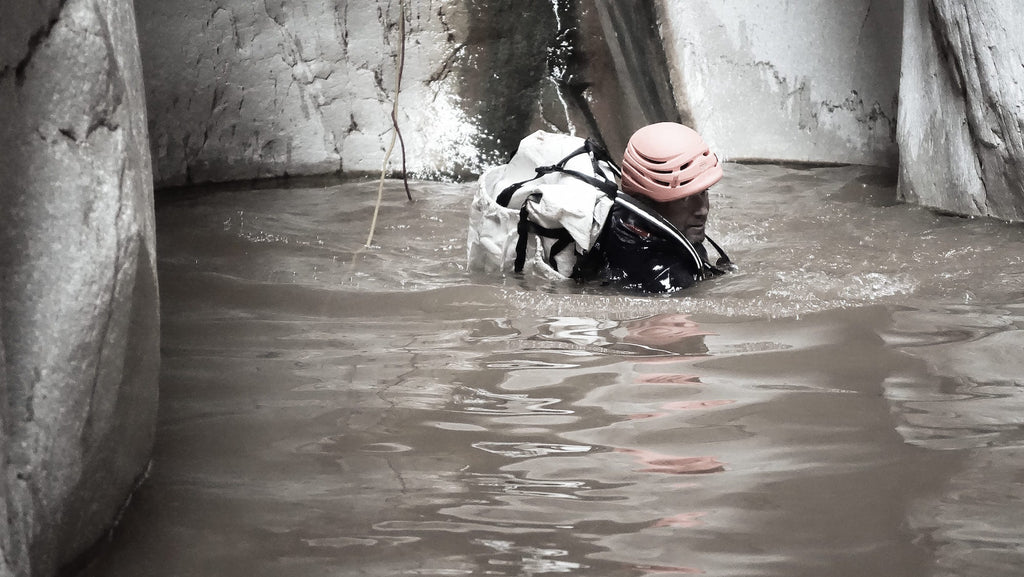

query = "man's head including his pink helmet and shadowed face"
[[622, 122, 722, 243]]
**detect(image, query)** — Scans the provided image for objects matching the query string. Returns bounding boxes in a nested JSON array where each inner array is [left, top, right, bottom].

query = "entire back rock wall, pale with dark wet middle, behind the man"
[[136, 0, 901, 186]]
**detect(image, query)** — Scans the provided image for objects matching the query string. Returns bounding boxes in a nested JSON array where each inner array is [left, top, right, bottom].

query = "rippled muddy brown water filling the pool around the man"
[[86, 165, 1024, 577]]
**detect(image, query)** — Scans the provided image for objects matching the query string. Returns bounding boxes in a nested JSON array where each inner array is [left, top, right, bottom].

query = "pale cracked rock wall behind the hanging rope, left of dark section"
[[136, 0, 491, 184]]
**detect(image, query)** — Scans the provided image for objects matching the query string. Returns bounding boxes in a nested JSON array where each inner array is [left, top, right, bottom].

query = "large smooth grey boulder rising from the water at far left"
[[0, 0, 159, 576]]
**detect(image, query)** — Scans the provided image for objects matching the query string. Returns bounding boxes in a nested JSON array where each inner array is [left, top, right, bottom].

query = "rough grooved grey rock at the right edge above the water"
[[899, 0, 1024, 220]]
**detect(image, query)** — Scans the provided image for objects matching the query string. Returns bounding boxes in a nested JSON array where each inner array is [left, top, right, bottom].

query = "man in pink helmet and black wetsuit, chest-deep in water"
[[573, 122, 732, 292]]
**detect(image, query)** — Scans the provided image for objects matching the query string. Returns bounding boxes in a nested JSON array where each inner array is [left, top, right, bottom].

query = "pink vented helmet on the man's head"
[[623, 122, 722, 202]]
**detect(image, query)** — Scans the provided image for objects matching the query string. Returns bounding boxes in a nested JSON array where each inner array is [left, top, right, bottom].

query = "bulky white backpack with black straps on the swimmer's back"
[[467, 131, 731, 292]]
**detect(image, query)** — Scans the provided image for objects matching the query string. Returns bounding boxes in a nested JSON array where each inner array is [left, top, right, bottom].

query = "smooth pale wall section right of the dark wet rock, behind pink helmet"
[[660, 0, 902, 166]]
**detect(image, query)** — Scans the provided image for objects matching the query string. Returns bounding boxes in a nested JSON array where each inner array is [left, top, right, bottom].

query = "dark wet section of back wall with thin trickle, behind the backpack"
[[460, 0, 691, 167]]
